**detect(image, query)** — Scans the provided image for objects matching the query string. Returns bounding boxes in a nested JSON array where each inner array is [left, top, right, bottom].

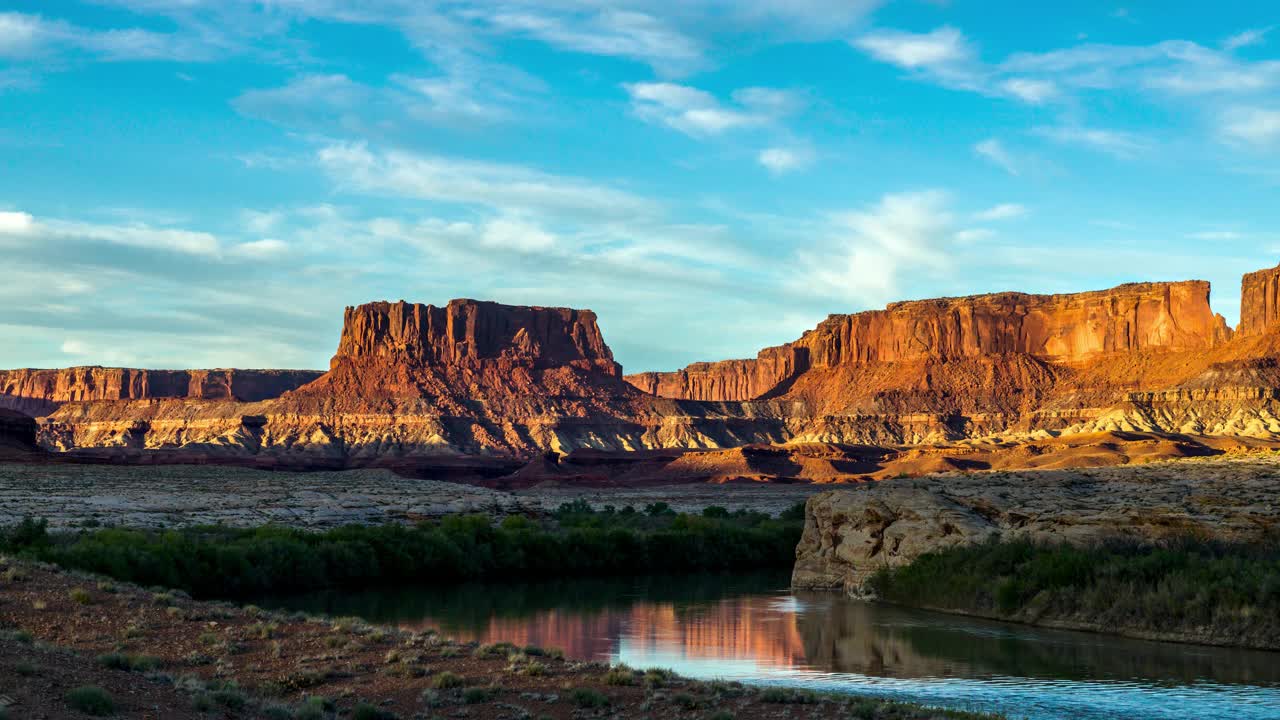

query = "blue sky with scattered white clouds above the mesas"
[[0, 0, 1280, 372]]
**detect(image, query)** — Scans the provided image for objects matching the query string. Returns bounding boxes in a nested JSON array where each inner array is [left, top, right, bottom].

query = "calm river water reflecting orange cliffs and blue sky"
[[262, 575, 1280, 720]]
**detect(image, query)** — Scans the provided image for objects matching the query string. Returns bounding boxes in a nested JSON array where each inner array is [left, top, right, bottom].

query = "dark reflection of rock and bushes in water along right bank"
[[795, 593, 1280, 684]]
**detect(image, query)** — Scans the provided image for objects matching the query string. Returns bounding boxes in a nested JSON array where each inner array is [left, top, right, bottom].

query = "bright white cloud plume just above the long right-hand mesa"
[[797, 191, 955, 305]]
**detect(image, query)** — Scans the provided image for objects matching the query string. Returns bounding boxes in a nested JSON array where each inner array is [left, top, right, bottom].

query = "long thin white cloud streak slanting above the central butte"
[[316, 143, 657, 219]]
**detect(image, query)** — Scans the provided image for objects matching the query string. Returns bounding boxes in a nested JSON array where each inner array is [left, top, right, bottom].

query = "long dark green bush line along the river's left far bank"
[[0, 503, 801, 598]]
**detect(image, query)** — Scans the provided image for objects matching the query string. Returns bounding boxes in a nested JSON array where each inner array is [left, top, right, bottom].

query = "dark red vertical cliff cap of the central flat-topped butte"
[[330, 300, 622, 378]]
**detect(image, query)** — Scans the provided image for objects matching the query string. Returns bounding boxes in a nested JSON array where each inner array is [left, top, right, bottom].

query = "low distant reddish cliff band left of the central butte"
[[0, 366, 321, 416]]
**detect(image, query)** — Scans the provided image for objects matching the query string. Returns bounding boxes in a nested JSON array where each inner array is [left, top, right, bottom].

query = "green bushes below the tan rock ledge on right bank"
[[868, 538, 1280, 644]]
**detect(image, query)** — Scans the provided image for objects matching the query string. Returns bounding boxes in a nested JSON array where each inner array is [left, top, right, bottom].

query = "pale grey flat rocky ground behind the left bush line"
[[0, 462, 818, 528]]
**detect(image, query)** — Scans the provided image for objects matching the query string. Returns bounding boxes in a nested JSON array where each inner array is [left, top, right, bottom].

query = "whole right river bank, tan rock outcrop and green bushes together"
[[792, 457, 1280, 650]]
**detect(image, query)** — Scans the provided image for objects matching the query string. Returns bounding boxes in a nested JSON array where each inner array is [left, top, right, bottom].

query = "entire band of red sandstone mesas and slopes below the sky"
[[0, 262, 1280, 466]]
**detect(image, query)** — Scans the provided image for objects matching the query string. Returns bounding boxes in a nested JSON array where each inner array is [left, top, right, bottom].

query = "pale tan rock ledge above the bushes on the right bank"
[[792, 459, 1280, 594]]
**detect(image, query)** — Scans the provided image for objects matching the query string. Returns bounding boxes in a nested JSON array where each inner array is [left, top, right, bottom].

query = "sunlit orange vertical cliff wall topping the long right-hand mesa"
[[628, 281, 1231, 401]]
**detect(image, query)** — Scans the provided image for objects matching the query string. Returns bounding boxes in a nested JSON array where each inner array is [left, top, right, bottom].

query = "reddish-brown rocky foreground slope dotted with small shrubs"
[[0, 559, 993, 720]]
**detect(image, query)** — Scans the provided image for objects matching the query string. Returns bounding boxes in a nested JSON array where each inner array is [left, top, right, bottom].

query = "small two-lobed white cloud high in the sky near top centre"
[[622, 82, 801, 137]]
